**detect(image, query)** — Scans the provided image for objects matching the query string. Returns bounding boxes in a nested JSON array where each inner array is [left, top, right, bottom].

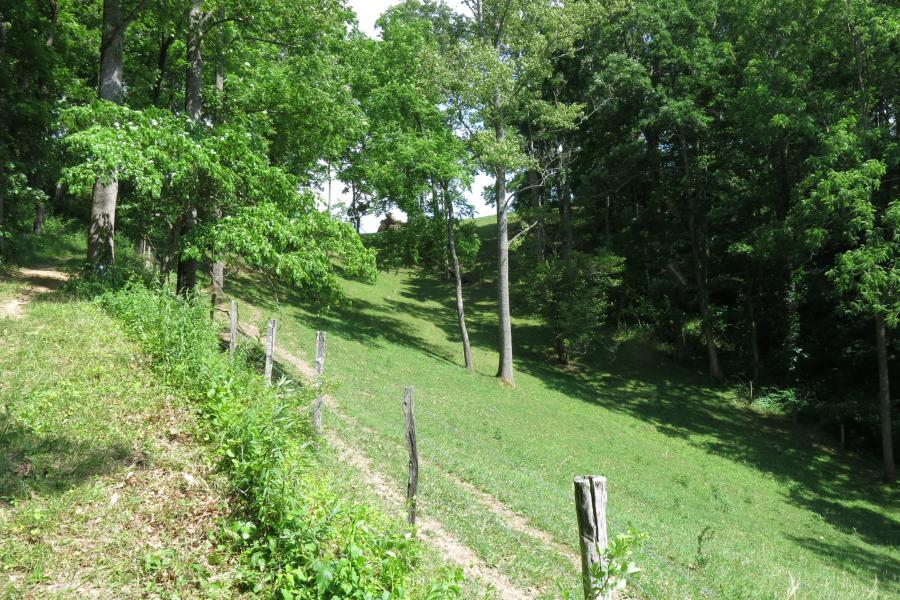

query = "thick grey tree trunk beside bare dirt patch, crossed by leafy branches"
[[87, 0, 126, 267]]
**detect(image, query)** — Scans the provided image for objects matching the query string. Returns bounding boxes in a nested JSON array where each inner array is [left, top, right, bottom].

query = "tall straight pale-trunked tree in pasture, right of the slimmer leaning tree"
[[448, 0, 600, 385]]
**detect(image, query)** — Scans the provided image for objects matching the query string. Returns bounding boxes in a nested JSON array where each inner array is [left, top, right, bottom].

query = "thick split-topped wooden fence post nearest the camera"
[[575, 476, 612, 600]]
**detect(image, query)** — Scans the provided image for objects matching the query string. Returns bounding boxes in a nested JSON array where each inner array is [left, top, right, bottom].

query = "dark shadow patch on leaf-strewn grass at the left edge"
[[0, 416, 134, 502]]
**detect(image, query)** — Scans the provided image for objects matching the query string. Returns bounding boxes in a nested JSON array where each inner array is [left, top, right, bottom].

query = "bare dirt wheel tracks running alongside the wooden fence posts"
[[230, 322, 580, 600]]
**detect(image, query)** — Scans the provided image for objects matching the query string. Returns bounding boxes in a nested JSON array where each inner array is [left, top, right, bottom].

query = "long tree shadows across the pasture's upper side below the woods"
[[227, 264, 900, 568]]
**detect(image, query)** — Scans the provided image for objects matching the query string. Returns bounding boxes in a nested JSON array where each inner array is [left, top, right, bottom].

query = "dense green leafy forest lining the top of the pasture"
[[0, 0, 900, 492]]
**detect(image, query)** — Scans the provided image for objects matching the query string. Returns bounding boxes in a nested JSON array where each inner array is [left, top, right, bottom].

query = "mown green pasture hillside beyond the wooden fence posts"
[[230, 217, 900, 599]]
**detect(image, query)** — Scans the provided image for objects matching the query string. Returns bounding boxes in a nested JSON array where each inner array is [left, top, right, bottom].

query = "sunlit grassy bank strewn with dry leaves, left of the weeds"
[[0, 241, 239, 598]]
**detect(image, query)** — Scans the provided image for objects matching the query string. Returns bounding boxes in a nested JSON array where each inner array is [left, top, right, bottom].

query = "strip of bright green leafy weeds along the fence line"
[[94, 282, 460, 599]]
